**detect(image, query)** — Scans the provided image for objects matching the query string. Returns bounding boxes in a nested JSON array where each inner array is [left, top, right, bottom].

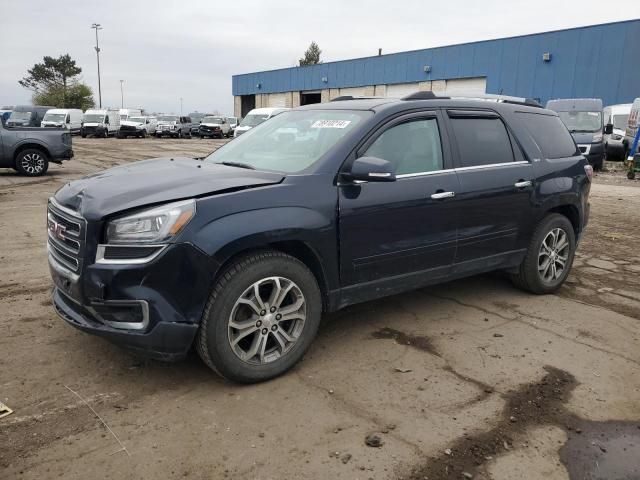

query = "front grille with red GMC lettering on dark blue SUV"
[[47, 200, 87, 273]]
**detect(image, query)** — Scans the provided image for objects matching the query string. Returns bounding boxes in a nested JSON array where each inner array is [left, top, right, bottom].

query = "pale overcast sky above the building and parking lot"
[[0, 0, 640, 114]]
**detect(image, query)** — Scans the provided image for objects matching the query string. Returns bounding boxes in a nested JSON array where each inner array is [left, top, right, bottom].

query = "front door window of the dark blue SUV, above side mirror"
[[365, 118, 443, 175]]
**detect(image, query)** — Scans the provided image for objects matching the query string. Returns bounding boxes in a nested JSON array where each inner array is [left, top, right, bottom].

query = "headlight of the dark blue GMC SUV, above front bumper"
[[107, 200, 196, 243]]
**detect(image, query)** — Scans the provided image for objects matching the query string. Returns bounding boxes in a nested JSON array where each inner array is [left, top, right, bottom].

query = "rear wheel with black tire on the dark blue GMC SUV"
[[511, 213, 576, 295]]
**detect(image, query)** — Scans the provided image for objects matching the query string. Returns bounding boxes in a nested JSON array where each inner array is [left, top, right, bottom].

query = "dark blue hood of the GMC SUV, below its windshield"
[[55, 158, 284, 220]]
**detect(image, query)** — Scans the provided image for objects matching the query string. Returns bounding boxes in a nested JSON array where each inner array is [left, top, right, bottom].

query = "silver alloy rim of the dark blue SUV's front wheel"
[[228, 277, 307, 365]]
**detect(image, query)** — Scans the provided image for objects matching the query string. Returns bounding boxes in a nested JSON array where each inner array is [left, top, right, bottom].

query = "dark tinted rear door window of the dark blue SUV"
[[451, 117, 513, 167]]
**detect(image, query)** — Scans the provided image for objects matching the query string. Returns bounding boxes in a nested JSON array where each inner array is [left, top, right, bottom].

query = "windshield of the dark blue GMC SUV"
[[205, 110, 370, 173]]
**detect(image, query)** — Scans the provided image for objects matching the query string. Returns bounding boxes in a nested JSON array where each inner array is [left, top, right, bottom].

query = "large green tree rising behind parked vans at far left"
[[18, 54, 94, 108]]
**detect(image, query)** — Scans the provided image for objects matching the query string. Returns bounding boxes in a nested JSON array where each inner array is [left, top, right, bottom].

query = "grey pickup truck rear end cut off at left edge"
[[0, 123, 73, 177]]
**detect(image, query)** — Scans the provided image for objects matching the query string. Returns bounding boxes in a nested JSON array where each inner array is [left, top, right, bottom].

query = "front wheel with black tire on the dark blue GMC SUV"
[[196, 250, 322, 383]]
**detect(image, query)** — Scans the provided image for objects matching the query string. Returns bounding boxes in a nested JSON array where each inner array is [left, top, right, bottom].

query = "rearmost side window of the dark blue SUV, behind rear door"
[[517, 112, 579, 158]]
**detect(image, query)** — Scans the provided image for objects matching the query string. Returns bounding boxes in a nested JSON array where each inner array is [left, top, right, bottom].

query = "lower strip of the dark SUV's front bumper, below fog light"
[[53, 288, 198, 361]]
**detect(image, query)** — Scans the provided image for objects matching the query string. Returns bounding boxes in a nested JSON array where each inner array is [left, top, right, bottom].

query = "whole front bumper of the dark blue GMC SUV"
[[49, 244, 216, 360]]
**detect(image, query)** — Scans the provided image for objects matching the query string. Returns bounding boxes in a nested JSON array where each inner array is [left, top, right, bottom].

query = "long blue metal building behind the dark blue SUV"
[[232, 19, 640, 115]]
